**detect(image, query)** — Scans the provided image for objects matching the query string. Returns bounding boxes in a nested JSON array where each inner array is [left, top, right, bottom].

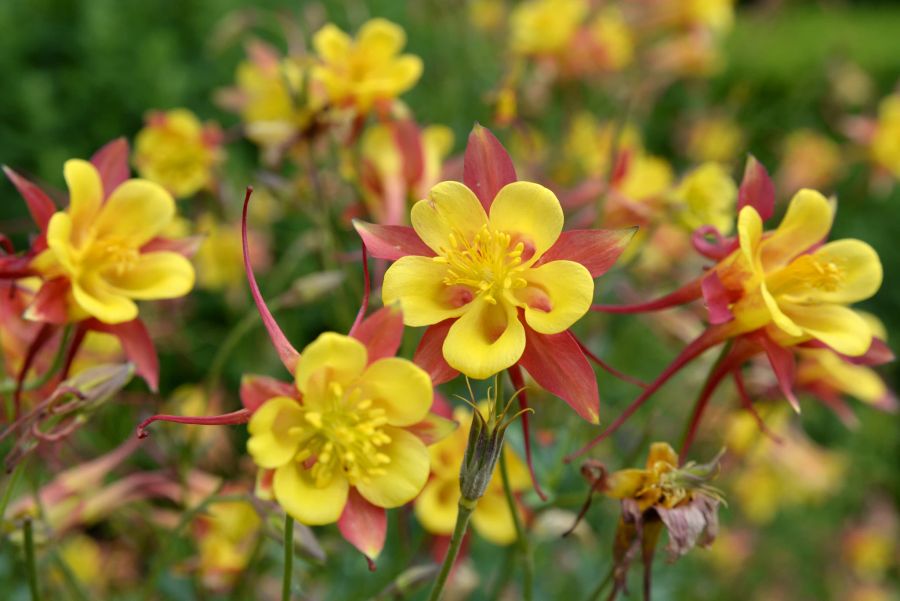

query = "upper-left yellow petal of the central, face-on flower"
[[410, 181, 487, 254]]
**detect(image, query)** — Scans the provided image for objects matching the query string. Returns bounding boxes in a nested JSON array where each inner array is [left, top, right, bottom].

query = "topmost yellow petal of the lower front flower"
[[295, 332, 368, 400]]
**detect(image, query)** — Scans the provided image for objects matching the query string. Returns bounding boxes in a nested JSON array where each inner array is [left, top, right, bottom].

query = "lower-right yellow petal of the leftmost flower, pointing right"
[[103, 251, 194, 300]]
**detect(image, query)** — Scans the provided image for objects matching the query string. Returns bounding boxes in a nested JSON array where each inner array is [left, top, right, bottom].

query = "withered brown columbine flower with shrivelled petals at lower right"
[[582, 442, 723, 599]]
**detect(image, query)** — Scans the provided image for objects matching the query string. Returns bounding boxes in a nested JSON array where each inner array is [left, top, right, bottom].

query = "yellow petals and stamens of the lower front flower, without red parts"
[[247, 332, 433, 525]]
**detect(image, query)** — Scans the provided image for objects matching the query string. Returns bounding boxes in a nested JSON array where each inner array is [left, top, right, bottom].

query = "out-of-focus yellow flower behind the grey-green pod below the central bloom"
[[415, 408, 531, 545]]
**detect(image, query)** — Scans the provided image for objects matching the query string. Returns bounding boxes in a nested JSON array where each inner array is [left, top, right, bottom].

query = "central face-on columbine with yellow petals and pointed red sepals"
[[356, 126, 633, 423]]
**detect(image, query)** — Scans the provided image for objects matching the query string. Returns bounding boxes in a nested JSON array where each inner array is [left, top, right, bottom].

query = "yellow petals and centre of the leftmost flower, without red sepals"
[[31, 159, 194, 324]]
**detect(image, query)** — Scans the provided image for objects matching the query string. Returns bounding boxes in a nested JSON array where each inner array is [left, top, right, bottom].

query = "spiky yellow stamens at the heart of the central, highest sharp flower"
[[434, 225, 528, 304]]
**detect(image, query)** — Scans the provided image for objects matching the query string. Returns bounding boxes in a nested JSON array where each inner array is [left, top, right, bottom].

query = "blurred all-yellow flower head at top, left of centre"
[[312, 19, 422, 113]]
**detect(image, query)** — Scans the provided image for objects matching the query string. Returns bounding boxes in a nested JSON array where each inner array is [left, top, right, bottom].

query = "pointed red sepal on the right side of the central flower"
[[535, 227, 638, 278]]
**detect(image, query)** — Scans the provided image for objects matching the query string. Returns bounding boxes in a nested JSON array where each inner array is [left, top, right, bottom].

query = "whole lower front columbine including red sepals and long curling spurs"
[[138, 189, 454, 562]]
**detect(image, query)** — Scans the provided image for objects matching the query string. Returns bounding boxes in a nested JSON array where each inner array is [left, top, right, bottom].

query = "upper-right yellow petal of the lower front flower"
[[359, 357, 434, 426]]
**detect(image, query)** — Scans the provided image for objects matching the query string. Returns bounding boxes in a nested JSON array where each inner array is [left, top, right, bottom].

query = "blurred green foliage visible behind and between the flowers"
[[0, 0, 900, 600]]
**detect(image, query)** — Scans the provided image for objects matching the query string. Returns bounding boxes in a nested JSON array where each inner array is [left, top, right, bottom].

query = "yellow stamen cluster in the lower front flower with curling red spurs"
[[292, 382, 391, 488]]
